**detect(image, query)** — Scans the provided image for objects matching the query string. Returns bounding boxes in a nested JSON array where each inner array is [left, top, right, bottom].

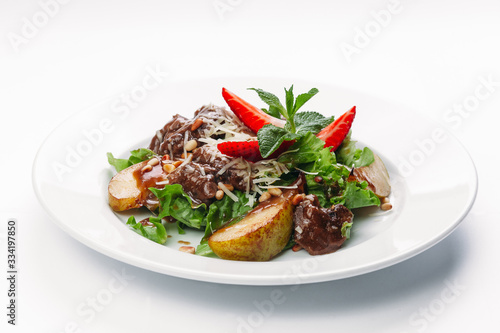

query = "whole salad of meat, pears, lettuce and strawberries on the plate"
[[108, 86, 392, 261]]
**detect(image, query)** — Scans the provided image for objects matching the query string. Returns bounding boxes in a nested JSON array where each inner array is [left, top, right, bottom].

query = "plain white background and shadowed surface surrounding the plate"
[[0, 0, 500, 332]]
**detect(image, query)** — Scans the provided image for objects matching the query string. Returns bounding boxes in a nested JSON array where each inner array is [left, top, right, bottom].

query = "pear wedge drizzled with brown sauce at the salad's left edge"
[[108, 157, 167, 212]]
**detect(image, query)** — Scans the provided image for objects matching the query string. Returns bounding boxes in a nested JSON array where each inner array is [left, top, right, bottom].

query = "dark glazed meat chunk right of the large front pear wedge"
[[294, 194, 353, 255]]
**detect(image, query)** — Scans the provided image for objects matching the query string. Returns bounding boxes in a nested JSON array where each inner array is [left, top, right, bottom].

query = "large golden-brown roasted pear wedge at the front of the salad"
[[208, 184, 299, 261]]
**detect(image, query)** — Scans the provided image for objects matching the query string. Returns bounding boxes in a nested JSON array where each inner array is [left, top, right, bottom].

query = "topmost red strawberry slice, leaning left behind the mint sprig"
[[222, 88, 285, 133]]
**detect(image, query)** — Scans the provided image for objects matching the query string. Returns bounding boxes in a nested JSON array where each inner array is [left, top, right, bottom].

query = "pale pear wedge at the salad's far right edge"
[[353, 154, 391, 198]]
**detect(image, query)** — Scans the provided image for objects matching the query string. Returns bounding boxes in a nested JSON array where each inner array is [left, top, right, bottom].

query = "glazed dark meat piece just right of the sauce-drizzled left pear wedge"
[[168, 162, 217, 204]]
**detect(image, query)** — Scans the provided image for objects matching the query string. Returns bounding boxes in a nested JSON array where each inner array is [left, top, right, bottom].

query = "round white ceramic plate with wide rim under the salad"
[[33, 78, 477, 285]]
